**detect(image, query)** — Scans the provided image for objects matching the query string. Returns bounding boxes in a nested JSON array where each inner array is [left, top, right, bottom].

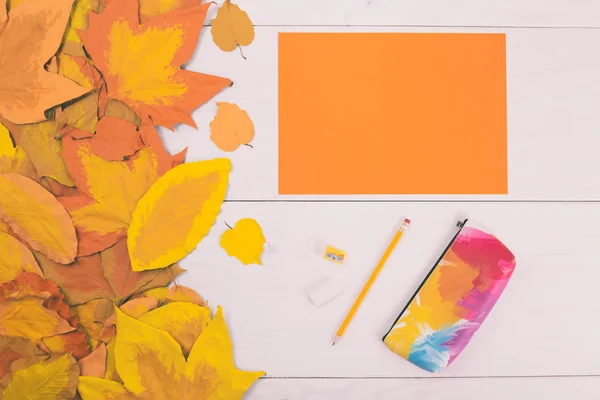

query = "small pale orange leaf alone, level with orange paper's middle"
[[210, 103, 254, 151]]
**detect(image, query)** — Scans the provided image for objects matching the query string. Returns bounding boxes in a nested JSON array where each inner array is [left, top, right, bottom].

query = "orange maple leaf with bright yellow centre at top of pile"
[[79, 0, 231, 129]]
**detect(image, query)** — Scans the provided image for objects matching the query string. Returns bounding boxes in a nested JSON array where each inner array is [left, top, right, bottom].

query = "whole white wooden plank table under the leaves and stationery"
[[162, 0, 600, 400]]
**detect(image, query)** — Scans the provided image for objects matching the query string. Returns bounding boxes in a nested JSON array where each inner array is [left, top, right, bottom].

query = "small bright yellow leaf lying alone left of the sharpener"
[[221, 218, 266, 265]]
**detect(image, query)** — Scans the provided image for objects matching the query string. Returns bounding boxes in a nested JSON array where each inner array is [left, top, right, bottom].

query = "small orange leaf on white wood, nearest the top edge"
[[211, 0, 254, 51]]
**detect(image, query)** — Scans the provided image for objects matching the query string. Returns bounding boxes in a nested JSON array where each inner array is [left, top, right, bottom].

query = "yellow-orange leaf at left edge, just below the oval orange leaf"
[[0, 232, 43, 284]]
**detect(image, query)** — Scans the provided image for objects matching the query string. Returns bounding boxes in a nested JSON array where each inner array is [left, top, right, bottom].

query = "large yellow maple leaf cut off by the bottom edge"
[[79, 307, 264, 400]]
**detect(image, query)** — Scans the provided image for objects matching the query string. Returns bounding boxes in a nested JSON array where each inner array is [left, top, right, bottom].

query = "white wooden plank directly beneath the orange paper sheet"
[[162, 28, 600, 200]]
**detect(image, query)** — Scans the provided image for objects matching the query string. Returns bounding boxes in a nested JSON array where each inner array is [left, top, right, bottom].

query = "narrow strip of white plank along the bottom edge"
[[245, 377, 600, 400]]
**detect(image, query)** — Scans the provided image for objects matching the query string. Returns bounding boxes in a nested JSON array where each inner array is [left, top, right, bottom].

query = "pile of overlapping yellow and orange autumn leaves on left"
[[0, 0, 263, 400]]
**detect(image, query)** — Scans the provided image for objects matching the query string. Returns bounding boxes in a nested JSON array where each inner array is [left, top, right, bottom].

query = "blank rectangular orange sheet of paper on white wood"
[[279, 33, 508, 194]]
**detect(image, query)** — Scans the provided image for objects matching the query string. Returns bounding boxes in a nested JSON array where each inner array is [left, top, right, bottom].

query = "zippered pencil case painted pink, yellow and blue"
[[383, 220, 515, 372]]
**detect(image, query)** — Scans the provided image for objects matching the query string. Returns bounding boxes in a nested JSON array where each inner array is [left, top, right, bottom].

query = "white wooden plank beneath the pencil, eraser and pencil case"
[[179, 202, 600, 377]]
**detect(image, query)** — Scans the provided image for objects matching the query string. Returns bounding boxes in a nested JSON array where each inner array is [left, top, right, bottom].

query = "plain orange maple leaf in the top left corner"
[[0, 0, 89, 124]]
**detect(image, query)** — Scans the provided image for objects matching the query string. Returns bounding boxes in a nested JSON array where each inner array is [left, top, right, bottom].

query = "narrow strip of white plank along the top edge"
[[205, 0, 600, 27]]
